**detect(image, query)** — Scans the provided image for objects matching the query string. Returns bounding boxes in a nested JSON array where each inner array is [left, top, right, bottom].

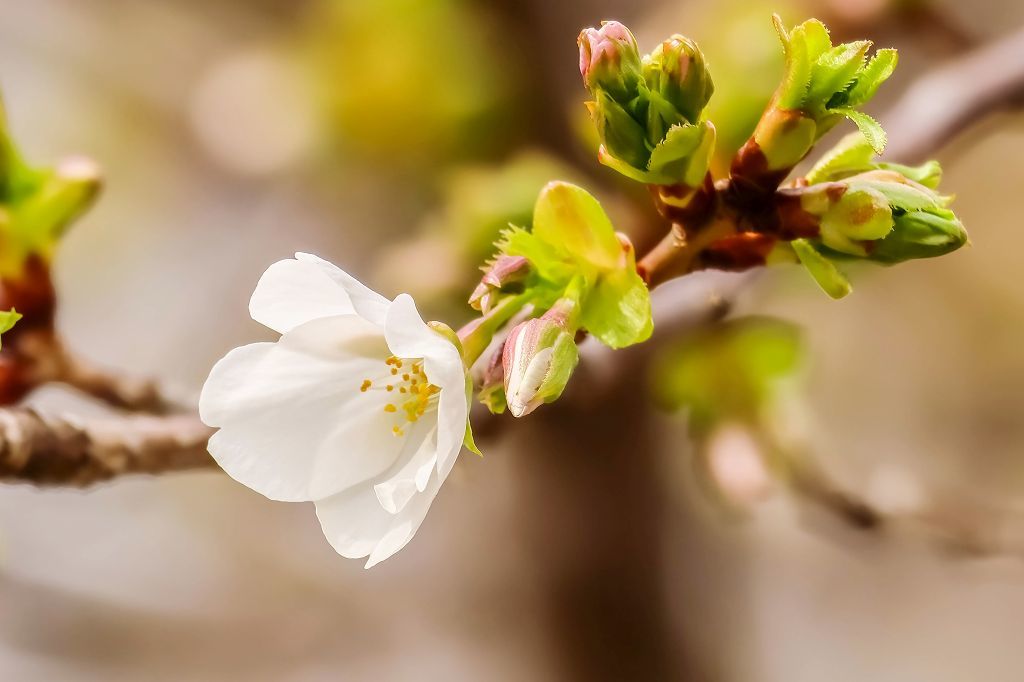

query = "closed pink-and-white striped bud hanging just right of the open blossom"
[[502, 299, 580, 417]]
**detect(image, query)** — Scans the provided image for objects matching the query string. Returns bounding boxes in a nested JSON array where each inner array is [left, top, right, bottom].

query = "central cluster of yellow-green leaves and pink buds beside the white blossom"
[[459, 182, 652, 417]]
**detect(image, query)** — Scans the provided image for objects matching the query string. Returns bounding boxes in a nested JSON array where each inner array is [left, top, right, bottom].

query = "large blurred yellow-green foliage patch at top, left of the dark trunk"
[[303, 0, 518, 168]]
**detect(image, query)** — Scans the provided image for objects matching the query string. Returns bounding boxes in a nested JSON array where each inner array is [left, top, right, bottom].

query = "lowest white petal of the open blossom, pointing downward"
[[316, 464, 443, 568]]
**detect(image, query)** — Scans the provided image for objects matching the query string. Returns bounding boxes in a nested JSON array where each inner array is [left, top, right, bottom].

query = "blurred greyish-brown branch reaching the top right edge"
[[882, 22, 1024, 162]]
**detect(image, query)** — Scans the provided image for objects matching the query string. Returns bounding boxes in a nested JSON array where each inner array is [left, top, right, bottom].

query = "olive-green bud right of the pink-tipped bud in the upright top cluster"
[[643, 34, 715, 129]]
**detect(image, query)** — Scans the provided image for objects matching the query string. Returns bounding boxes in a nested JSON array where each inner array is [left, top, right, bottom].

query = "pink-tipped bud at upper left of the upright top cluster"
[[577, 22, 640, 100]]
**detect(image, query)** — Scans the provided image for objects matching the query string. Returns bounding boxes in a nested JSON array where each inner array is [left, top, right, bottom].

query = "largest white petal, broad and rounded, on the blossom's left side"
[[200, 315, 403, 502]]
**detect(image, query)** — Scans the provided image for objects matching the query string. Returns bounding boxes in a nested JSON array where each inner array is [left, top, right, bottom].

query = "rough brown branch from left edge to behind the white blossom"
[[0, 409, 214, 486]]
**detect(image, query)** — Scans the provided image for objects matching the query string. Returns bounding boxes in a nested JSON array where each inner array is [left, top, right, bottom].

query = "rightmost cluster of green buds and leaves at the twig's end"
[[777, 133, 968, 298]]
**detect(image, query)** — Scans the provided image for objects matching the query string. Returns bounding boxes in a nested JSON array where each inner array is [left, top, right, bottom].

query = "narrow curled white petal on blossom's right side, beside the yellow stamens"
[[384, 294, 469, 475]]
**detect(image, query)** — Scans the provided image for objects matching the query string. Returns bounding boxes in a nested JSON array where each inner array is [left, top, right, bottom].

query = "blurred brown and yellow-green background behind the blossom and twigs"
[[0, 0, 1024, 682]]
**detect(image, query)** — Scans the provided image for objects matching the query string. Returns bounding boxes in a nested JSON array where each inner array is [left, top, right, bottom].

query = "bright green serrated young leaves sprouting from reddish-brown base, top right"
[[733, 15, 897, 188]]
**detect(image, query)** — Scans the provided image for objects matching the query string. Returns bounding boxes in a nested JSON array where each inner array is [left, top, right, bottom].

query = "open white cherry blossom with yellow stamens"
[[200, 253, 468, 568]]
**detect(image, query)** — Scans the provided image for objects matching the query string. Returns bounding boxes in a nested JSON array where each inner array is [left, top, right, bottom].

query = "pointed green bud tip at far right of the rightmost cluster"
[[869, 209, 967, 263]]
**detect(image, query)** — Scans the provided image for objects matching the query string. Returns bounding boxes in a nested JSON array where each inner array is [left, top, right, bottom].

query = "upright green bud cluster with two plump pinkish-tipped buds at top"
[[579, 22, 715, 187]]
